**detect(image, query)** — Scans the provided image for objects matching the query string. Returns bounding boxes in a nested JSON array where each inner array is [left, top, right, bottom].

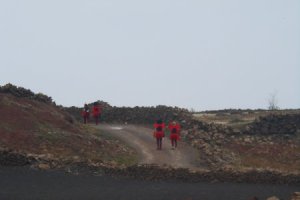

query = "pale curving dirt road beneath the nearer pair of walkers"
[[97, 124, 200, 170]]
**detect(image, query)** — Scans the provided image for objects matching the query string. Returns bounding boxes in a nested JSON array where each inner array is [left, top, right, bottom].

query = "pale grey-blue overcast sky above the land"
[[0, 0, 300, 110]]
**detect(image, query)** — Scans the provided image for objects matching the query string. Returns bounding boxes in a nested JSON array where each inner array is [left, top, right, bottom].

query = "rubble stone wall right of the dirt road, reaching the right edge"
[[182, 114, 300, 169]]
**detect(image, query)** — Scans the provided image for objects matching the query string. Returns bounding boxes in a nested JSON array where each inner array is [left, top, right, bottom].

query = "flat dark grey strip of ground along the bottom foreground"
[[0, 167, 300, 200]]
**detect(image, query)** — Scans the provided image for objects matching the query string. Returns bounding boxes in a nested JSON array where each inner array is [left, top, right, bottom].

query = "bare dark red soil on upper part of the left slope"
[[0, 94, 78, 149]]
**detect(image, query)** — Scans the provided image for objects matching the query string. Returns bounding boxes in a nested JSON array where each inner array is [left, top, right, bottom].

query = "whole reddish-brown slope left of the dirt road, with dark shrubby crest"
[[0, 84, 135, 170]]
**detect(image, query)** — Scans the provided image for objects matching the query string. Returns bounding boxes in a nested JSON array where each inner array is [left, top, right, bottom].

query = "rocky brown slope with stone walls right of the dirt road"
[[185, 110, 300, 173]]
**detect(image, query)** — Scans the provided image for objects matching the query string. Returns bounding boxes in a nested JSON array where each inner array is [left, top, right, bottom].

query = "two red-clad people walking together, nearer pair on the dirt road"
[[154, 119, 181, 150]]
